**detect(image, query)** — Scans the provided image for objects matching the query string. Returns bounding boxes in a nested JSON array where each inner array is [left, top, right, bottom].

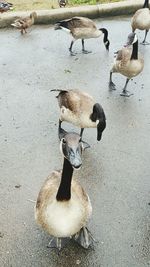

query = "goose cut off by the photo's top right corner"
[[131, 0, 150, 44]]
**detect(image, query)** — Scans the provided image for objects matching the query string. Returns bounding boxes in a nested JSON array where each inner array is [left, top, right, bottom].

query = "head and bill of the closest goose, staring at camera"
[[60, 131, 83, 169]]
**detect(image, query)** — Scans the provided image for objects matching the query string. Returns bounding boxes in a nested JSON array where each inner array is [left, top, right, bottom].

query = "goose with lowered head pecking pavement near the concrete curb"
[[55, 17, 110, 55]]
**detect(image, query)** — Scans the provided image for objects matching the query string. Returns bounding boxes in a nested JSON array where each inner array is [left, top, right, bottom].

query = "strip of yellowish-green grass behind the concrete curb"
[[10, 0, 122, 11]]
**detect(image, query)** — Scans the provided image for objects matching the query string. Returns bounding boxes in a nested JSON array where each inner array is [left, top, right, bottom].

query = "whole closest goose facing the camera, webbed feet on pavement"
[[35, 131, 92, 250]]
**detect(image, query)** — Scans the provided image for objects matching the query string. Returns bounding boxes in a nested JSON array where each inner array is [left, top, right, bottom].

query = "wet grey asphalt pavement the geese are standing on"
[[0, 17, 150, 267]]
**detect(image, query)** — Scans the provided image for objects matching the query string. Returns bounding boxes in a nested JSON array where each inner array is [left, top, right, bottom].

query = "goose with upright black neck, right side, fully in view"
[[109, 33, 144, 97]]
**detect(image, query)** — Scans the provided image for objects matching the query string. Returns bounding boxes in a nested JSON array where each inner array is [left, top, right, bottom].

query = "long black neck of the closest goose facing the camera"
[[56, 158, 73, 201]]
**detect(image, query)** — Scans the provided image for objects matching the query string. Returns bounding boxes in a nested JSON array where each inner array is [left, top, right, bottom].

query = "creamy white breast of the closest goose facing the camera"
[[44, 199, 88, 237]]
